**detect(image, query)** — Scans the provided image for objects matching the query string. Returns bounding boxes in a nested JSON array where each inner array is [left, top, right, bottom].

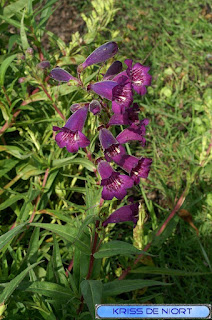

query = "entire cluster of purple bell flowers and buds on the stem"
[[50, 42, 152, 226]]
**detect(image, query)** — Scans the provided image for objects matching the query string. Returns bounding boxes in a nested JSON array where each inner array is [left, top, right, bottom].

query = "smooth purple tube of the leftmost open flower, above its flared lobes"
[[64, 106, 88, 131]]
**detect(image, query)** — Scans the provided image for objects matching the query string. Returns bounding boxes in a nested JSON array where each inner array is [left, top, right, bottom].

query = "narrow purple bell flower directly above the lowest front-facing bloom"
[[99, 128, 126, 164]]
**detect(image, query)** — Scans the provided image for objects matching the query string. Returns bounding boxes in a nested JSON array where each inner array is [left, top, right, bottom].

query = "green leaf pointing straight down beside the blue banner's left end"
[[80, 280, 103, 319]]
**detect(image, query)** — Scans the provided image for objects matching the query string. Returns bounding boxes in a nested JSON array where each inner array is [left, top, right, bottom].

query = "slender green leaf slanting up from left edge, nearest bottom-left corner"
[[0, 261, 42, 305]]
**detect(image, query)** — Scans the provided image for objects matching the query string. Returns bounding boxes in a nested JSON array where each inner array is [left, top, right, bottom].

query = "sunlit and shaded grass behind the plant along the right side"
[[113, 0, 212, 303]]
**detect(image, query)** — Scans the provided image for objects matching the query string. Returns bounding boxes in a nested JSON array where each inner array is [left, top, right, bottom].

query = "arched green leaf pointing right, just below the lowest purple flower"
[[94, 240, 150, 259]]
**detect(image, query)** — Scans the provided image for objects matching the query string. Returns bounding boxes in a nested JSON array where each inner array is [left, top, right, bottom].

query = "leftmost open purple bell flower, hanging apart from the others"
[[53, 107, 90, 152]]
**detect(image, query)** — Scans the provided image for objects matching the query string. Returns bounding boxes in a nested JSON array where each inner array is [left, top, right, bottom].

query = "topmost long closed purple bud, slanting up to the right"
[[78, 41, 118, 73]]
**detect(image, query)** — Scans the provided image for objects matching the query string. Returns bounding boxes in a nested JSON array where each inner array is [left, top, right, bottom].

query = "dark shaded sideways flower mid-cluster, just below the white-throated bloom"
[[109, 103, 139, 126]]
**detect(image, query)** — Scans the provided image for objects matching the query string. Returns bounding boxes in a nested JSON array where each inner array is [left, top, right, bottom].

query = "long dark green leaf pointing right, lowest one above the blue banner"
[[103, 279, 170, 296]]
